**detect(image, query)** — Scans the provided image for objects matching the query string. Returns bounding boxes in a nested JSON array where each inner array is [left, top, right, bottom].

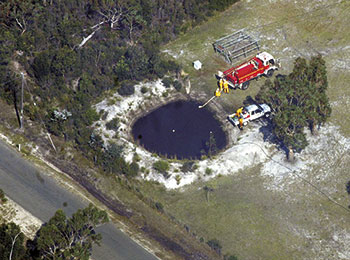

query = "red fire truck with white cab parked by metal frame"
[[216, 52, 280, 90]]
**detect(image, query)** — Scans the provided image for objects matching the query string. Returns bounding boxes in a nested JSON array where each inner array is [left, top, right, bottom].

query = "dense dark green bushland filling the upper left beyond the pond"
[[0, 0, 237, 177]]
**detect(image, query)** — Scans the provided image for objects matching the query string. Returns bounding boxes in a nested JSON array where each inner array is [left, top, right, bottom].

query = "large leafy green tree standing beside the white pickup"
[[256, 55, 331, 158]]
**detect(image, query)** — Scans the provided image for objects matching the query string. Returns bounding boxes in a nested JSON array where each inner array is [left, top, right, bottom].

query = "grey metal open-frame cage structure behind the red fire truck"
[[213, 29, 260, 64]]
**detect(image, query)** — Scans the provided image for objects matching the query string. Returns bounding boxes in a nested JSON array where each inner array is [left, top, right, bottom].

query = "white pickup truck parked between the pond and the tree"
[[227, 104, 271, 126]]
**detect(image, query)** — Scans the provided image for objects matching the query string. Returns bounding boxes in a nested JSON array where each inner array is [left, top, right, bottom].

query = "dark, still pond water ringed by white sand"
[[132, 101, 227, 159]]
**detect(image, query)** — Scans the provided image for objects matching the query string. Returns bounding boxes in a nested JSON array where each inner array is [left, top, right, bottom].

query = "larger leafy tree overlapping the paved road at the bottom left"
[[30, 204, 108, 260]]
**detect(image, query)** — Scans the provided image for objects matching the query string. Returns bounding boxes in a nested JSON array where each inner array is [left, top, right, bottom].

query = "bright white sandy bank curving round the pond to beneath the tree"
[[92, 81, 350, 190]]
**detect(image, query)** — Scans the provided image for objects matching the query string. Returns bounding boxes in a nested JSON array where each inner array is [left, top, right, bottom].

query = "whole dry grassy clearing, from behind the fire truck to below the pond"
[[148, 0, 350, 259]]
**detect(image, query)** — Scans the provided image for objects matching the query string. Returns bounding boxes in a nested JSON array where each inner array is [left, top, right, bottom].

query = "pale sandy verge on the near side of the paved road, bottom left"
[[0, 197, 43, 239]]
